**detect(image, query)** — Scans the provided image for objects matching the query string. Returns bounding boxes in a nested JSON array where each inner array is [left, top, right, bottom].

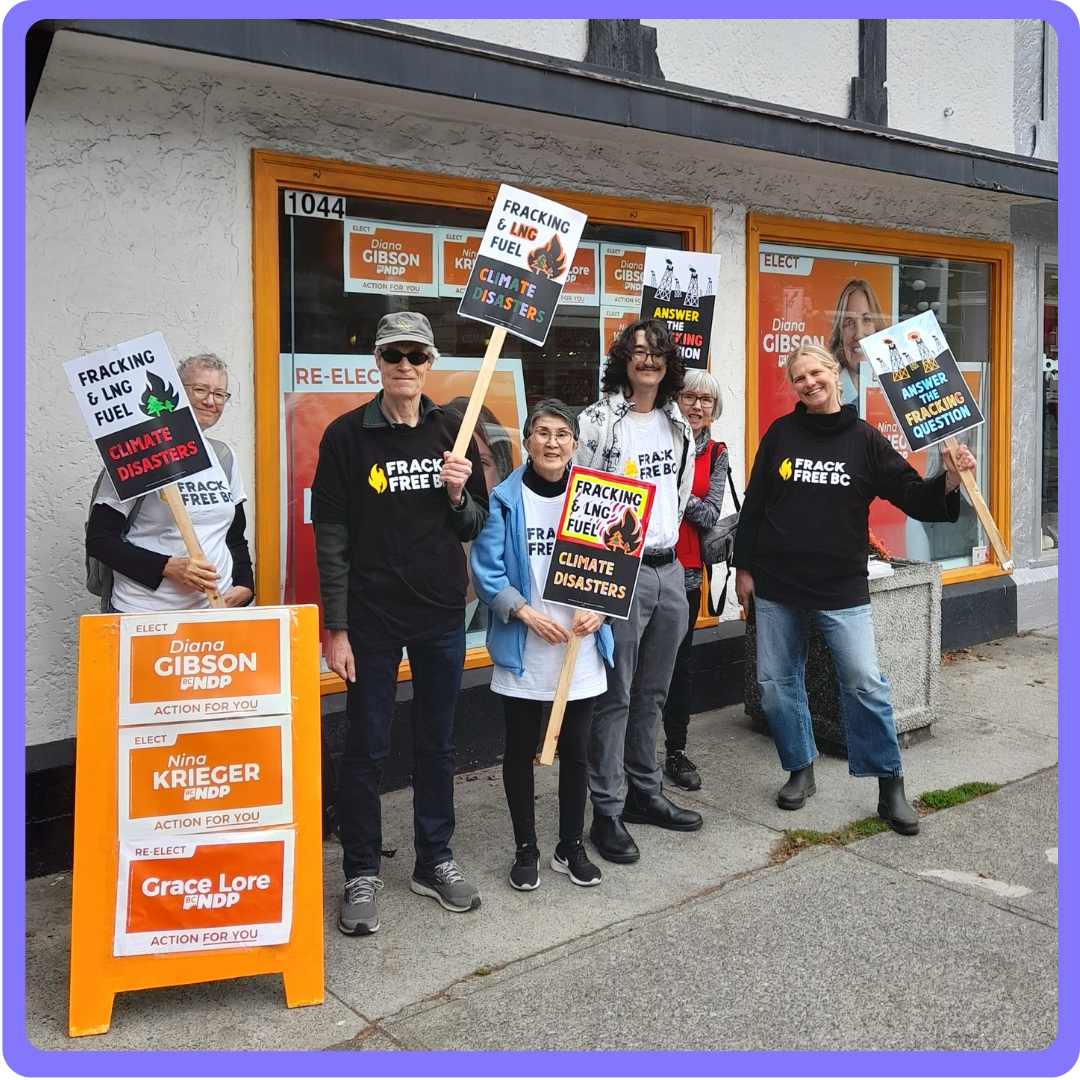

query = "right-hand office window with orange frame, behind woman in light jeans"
[[747, 215, 1010, 581]]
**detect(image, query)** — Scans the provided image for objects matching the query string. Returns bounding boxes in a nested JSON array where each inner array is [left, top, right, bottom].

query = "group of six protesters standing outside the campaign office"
[[86, 311, 975, 935]]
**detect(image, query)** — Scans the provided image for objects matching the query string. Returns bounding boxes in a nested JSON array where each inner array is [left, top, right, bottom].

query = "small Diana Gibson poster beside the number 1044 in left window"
[[342, 217, 438, 296]]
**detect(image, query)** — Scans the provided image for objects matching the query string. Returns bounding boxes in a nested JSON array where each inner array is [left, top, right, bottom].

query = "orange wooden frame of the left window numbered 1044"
[[252, 150, 717, 693]]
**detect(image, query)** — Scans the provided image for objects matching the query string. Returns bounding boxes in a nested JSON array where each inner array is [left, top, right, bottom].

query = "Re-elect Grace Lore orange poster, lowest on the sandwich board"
[[112, 828, 295, 956]]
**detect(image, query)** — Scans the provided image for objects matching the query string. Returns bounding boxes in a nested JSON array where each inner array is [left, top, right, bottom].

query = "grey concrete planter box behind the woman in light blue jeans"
[[745, 561, 942, 757]]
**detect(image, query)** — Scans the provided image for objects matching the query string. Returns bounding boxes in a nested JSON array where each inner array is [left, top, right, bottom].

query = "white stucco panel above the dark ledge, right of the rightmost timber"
[[888, 18, 1016, 153]]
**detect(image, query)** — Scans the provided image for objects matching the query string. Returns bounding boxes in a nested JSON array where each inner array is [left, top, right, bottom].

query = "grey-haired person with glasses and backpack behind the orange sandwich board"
[[86, 353, 255, 611]]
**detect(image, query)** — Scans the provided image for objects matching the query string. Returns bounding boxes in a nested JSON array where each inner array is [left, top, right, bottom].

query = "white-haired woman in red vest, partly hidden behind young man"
[[664, 367, 728, 792]]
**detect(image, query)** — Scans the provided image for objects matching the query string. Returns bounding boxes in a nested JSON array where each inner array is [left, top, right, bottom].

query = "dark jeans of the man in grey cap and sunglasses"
[[337, 623, 465, 880]]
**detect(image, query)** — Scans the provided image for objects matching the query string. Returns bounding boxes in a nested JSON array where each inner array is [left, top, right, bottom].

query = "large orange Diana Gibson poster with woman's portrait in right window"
[[757, 244, 900, 440]]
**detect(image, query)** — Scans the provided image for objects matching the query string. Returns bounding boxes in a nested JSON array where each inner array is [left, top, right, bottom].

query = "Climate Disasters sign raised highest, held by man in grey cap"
[[458, 184, 585, 345]]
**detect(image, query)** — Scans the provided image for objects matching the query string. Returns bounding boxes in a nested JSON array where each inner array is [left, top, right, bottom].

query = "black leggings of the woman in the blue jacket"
[[502, 696, 596, 847]]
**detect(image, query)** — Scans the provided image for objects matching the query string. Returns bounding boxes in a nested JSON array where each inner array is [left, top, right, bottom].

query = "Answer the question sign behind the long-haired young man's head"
[[642, 247, 720, 367]]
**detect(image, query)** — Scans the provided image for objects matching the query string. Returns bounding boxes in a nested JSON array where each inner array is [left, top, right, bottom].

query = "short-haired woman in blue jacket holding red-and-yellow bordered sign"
[[470, 397, 612, 890]]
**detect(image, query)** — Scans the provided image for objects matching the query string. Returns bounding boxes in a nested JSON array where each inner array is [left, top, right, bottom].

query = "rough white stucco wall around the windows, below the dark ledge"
[[26, 32, 1019, 744]]
